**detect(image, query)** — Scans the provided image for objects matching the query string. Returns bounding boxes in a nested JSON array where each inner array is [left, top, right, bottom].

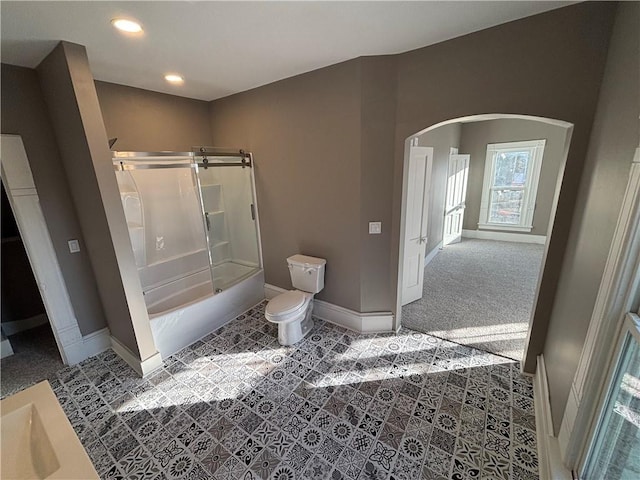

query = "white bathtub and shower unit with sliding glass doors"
[[113, 148, 264, 357]]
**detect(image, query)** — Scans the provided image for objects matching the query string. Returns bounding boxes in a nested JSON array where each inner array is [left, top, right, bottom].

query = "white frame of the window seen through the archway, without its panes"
[[478, 139, 547, 232]]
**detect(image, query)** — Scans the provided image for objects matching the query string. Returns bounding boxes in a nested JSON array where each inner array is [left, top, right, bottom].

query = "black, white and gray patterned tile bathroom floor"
[[25, 304, 538, 480]]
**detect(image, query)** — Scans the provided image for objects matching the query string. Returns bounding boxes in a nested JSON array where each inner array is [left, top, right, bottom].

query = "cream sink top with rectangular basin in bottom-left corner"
[[0, 382, 99, 480]]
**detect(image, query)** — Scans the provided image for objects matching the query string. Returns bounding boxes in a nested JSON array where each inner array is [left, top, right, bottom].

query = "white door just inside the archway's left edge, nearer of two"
[[402, 147, 433, 305]]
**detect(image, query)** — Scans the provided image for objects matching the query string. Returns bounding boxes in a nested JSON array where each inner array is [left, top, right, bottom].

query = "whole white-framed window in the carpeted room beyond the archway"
[[478, 140, 546, 232]]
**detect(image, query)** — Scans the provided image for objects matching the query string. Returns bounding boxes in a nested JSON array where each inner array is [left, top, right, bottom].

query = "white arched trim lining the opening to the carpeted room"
[[393, 113, 573, 350]]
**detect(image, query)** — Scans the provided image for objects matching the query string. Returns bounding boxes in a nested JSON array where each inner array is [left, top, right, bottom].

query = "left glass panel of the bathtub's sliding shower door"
[[116, 156, 213, 315]]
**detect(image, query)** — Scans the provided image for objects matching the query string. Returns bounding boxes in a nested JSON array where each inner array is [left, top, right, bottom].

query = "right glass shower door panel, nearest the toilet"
[[196, 154, 261, 292]]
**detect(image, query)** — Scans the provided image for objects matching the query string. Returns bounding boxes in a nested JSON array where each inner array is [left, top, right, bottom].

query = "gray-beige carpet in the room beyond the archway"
[[402, 239, 544, 360]]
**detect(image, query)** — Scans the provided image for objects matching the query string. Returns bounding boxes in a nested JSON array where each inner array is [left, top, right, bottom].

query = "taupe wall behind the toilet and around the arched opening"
[[211, 2, 616, 334]]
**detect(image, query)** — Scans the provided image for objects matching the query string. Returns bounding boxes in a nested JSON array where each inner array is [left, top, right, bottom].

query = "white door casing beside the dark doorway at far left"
[[0, 134, 88, 365]]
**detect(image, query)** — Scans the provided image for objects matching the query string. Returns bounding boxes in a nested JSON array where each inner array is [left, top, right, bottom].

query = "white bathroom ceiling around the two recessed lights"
[[0, 0, 574, 100]]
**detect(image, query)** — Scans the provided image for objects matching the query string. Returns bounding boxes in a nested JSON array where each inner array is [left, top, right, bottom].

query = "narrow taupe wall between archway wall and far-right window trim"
[[544, 2, 640, 431]]
